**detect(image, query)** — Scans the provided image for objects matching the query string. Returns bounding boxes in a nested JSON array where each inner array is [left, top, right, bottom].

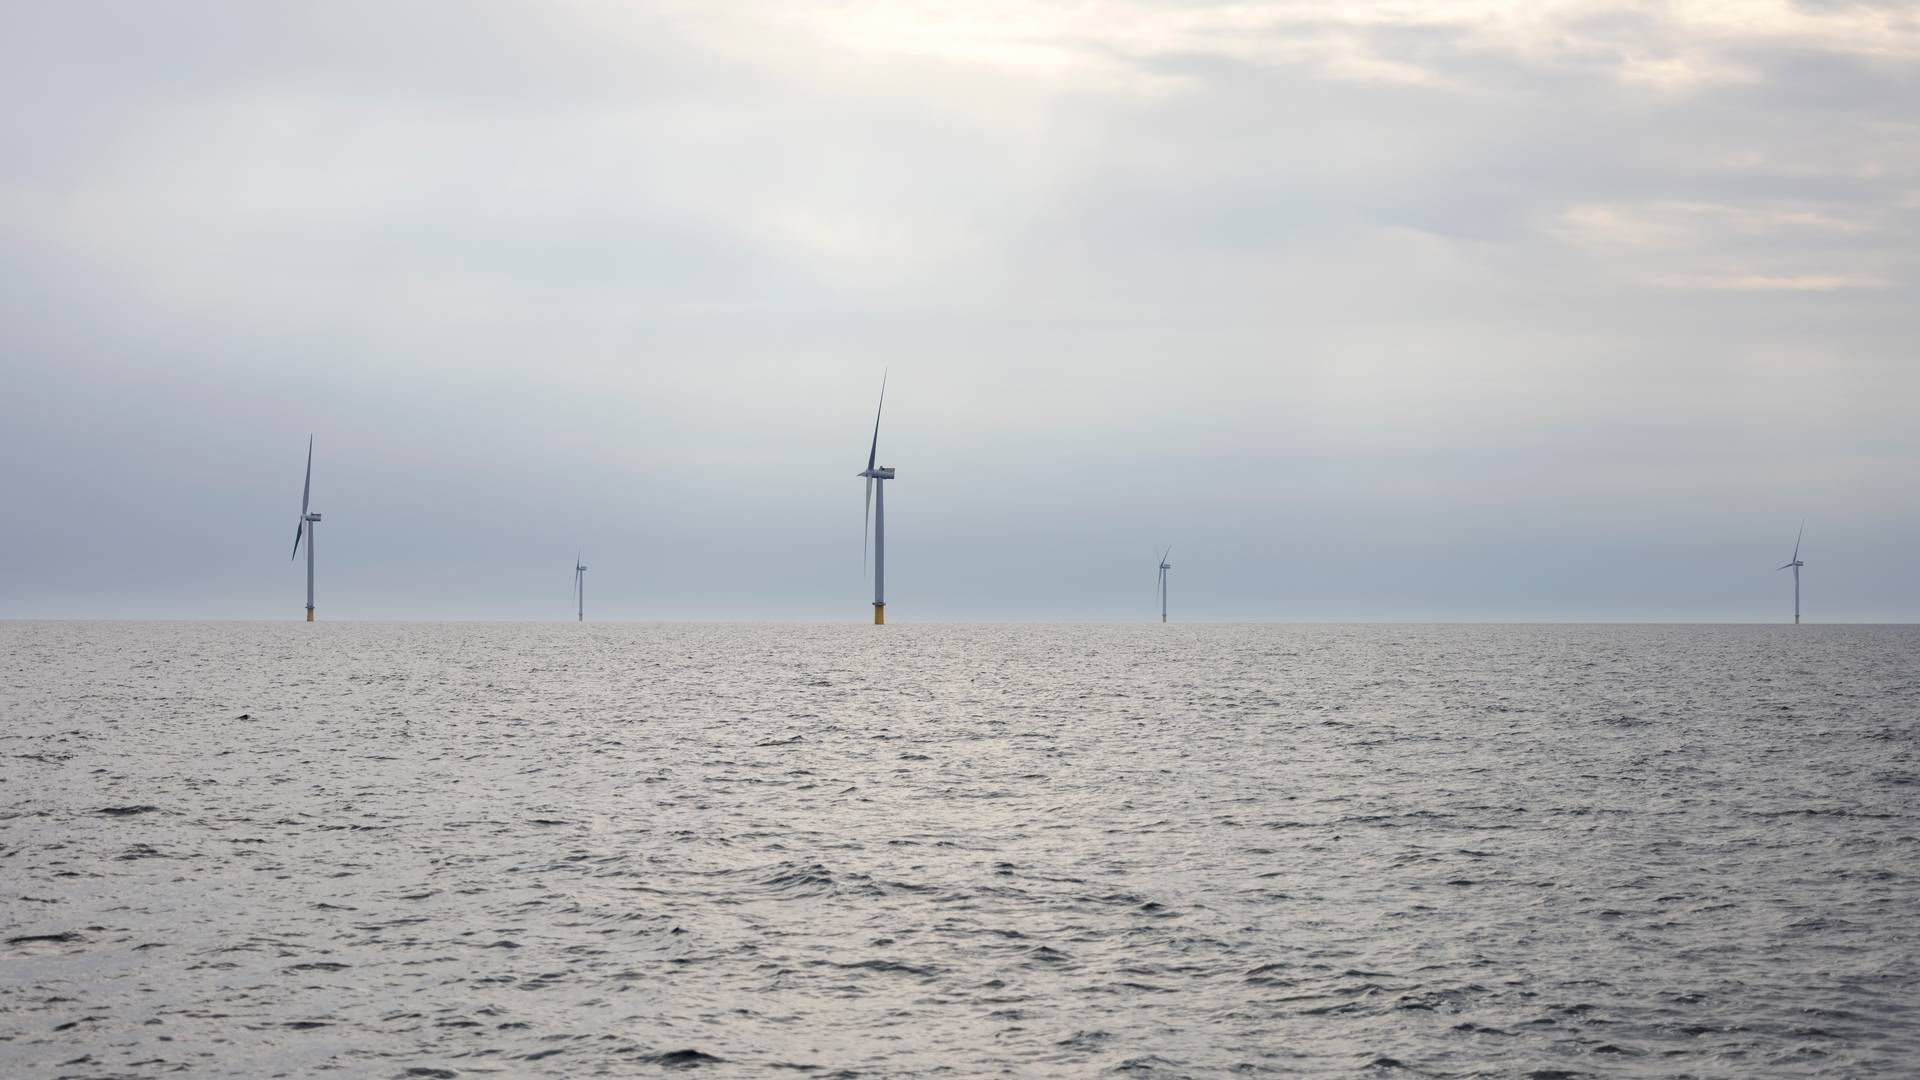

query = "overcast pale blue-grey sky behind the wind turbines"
[[0, 0, 1920, 623]]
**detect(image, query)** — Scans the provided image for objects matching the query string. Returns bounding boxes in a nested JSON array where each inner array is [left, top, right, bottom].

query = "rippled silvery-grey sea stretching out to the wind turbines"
[[0, 623, 1920, 1078]]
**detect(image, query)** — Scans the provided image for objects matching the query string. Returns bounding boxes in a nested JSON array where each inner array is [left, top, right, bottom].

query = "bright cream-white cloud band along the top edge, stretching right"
[[724, 0, 1920, 92]]
